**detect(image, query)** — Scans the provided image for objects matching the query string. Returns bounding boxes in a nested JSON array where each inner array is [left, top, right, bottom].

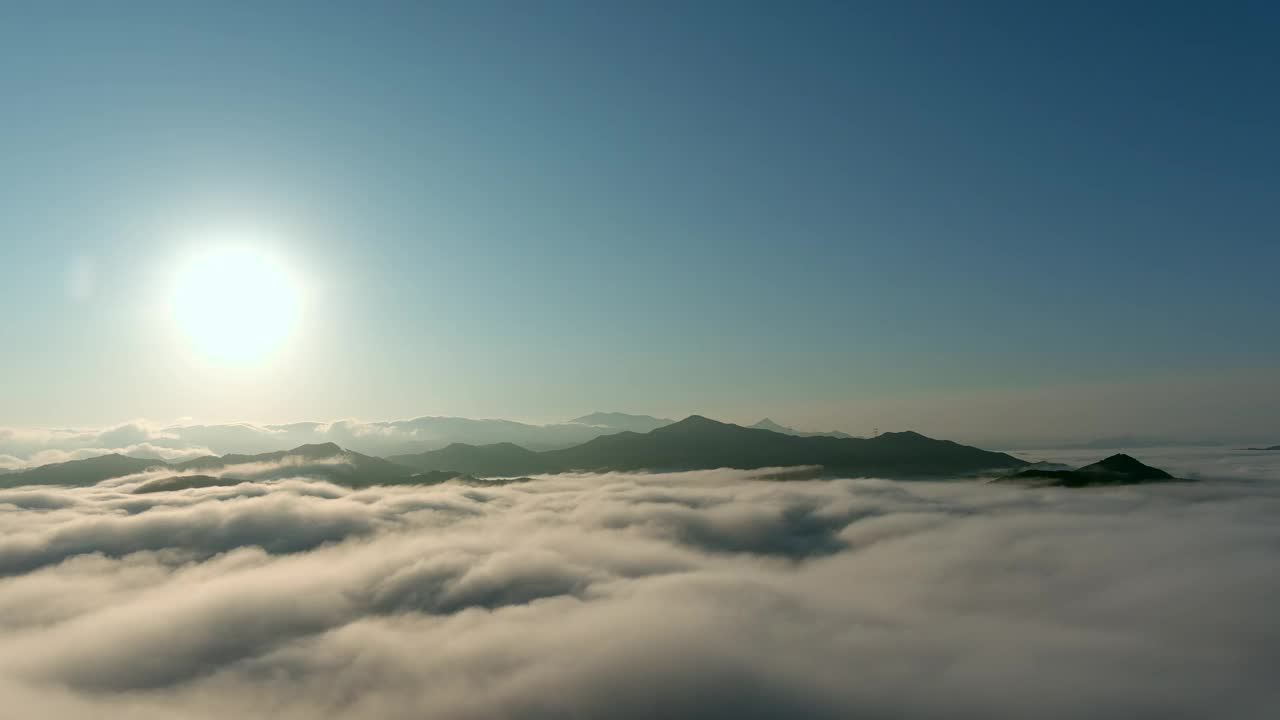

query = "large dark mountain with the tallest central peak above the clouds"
[[394, 415, 1027, 478]]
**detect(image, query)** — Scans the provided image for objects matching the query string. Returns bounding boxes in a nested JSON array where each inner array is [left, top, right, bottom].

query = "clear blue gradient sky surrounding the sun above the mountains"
[[0, 1, 1280, 437]]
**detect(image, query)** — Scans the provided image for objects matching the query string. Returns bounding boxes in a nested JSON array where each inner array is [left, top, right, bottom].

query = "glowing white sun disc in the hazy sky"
[[173, 247, 300, 365]]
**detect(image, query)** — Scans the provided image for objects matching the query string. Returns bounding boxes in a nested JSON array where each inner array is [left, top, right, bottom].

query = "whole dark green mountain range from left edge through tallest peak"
[[0, 415, 1028, 491]]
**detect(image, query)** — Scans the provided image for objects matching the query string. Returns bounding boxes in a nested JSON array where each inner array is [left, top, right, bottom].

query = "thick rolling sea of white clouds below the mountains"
[[0, 456, 1280, 720]]
